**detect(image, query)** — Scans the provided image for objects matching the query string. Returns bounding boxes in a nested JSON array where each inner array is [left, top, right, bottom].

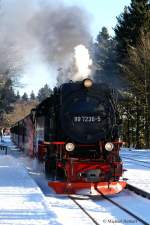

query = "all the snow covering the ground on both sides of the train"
[[0, 137, 150, 225]]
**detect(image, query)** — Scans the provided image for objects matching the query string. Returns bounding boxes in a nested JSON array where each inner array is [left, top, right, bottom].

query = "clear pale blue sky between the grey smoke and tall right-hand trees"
[[65, 0, 131, 37]]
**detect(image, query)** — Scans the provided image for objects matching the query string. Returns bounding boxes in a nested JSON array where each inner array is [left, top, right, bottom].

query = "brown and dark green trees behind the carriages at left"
[[0, 82, 52, 128]]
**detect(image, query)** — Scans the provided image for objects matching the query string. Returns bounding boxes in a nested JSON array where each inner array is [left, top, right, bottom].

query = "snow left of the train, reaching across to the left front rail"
[[0, 137, 93, 225]]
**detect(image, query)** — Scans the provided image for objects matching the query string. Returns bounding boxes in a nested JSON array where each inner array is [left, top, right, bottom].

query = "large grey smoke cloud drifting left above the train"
[[0, 0, 90, 89]]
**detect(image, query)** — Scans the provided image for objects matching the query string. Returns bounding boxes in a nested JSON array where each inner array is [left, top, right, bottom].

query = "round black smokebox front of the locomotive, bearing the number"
[[61, 83, 115, 144]]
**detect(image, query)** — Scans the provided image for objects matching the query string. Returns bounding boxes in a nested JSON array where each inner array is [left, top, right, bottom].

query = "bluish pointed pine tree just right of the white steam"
[[93, 27, 119, 86]]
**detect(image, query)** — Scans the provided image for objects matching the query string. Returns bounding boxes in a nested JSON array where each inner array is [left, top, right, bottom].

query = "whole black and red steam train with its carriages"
[[11, 79, 126, 195]]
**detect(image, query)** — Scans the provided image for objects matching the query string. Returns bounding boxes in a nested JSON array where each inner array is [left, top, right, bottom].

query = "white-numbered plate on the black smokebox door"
[[73, 116, 101, 123]]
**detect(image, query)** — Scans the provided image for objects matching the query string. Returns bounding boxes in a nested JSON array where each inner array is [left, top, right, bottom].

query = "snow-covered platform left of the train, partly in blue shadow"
[[0, 155, 58, 225]]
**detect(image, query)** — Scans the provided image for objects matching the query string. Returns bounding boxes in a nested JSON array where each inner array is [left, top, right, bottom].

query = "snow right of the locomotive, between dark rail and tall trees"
[[121, 149, 150, 193]]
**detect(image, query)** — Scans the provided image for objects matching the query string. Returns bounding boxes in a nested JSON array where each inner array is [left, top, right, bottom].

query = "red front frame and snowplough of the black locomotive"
[[44, 141, 126, 195]]
